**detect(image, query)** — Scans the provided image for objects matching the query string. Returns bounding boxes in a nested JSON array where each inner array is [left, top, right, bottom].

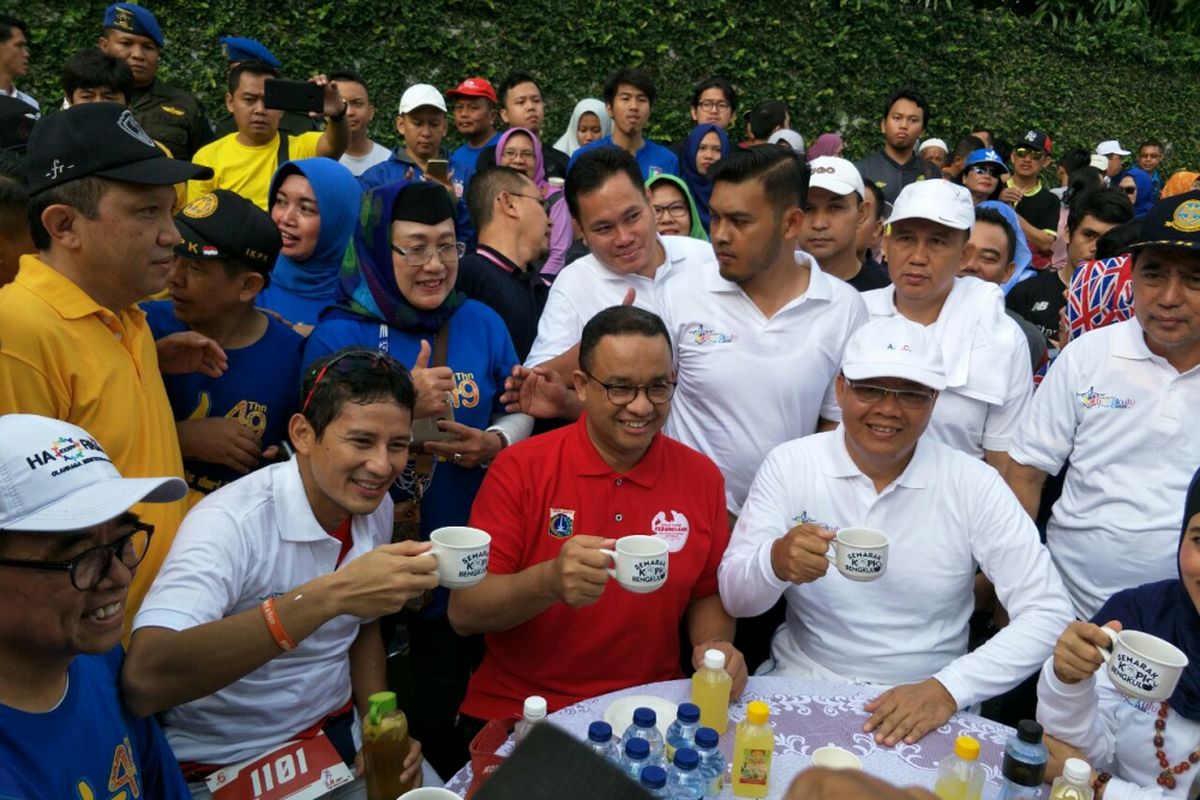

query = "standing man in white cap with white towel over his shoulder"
[[863, 180, 1033, 475]]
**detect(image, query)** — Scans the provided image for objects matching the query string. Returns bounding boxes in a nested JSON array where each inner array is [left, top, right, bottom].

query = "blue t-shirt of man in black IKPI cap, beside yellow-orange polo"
[[142, 300, 304, 494]]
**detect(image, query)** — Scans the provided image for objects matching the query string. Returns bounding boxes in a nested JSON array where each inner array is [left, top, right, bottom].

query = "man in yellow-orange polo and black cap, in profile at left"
[[0, 103, 213, 624]]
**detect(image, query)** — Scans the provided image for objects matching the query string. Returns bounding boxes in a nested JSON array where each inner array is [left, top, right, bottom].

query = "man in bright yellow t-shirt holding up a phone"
[[187, 61, 350, 211]]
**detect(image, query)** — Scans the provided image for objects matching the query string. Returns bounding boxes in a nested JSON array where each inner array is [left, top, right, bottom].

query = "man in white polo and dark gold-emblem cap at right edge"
[[1008, 192, 1200, 619]]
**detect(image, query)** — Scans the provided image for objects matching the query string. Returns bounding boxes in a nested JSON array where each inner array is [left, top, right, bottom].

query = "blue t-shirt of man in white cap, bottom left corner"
[[0, 645, 192, 800]]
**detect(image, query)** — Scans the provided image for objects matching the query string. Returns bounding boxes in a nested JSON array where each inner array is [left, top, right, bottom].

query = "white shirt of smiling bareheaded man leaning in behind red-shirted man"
[[526, 236, 713, 367]]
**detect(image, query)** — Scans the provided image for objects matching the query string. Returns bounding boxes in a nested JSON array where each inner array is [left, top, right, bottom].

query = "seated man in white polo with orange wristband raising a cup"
[[122, 349, 437, 798]]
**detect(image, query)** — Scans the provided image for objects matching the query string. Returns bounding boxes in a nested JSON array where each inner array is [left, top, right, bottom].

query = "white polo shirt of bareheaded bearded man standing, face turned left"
[[658, 253, 866, 513]]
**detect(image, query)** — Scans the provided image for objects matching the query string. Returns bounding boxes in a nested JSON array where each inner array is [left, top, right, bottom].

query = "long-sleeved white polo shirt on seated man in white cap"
[[718, 428, 1070, 708]]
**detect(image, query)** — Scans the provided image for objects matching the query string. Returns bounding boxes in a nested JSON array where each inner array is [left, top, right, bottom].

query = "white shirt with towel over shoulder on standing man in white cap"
[[863, 277, 1033, 458]]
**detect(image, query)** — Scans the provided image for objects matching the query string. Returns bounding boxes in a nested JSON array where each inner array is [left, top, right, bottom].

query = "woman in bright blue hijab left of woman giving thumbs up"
[[258, 158, 362, 327]]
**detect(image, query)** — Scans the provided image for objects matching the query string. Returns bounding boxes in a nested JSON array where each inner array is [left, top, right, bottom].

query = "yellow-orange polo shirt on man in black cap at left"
[[0, 255, 187, 633]]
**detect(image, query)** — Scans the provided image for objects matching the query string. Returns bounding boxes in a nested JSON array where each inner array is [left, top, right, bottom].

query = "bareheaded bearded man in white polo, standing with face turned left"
[[659, 145, 866, 516]]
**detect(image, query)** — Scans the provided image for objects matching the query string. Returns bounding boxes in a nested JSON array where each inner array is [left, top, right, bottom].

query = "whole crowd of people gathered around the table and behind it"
[[0, 2, 1200, 800]]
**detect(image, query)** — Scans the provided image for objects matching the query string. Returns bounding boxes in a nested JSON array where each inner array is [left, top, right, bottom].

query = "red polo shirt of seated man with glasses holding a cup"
[[462, 419, 730, 720]]
